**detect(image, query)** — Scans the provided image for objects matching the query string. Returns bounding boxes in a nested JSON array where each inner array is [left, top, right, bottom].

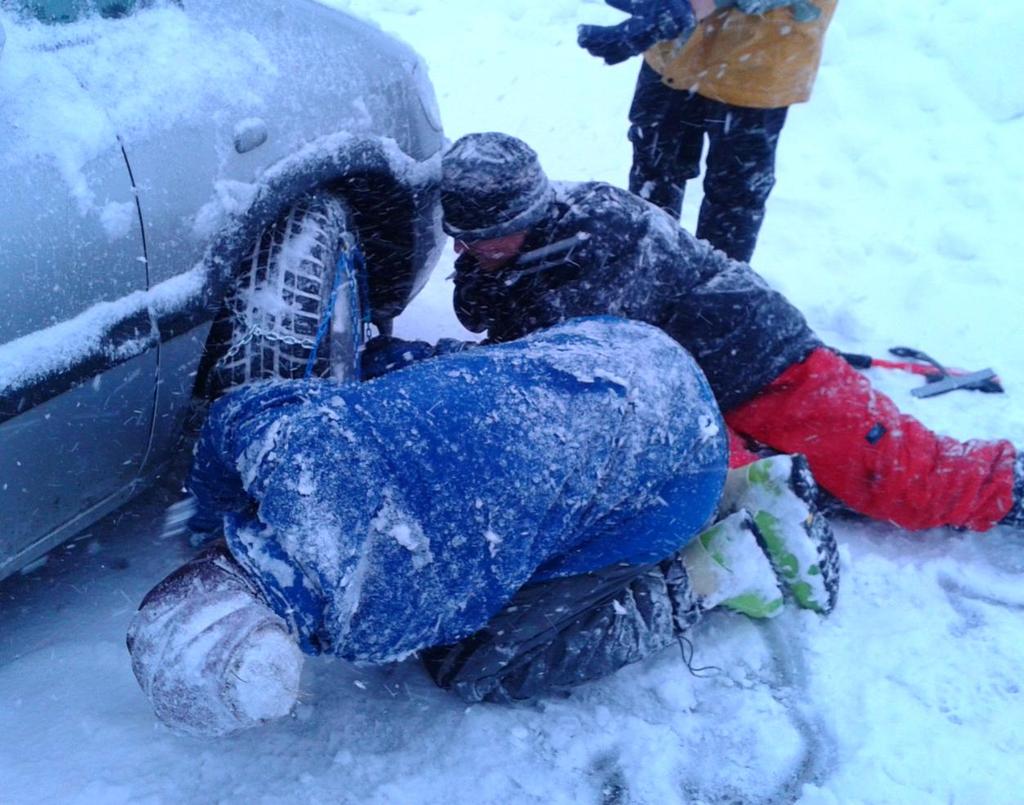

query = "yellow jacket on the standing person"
[[644, 0, 838, 109]]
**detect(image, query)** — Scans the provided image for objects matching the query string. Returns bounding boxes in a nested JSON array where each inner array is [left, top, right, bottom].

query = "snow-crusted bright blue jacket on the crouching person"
[[189, 317, 727, 662]]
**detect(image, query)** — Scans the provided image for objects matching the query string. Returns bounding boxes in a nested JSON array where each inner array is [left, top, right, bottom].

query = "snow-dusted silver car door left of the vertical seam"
[[0, 0, 158, 578]]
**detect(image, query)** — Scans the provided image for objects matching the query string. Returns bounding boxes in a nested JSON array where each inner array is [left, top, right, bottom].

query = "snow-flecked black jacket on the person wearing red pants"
[[455, 182, 820, 411]]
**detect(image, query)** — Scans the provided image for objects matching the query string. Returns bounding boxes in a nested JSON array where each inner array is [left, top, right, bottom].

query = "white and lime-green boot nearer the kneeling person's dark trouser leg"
[[679, 509, 782, 618]]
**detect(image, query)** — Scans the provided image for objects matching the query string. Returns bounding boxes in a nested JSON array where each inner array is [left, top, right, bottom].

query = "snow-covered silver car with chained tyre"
[[0, 0, 443, 579]]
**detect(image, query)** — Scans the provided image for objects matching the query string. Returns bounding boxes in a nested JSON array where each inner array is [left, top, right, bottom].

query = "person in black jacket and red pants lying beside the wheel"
[[441, 132, 1024, 531]]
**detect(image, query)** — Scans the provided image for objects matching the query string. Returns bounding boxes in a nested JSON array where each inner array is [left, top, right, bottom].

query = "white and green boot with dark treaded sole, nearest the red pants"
[[721, 455, 839, 615]]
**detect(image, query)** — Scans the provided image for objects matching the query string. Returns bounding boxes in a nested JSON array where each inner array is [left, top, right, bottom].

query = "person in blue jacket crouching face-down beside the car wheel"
[[128, 317, 839, 734]]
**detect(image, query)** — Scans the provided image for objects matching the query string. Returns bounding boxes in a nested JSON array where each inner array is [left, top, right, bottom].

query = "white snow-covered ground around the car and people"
[[0, 0, 1024, 804]]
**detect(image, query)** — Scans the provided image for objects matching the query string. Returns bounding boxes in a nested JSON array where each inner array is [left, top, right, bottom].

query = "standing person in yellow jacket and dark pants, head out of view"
[[581, 0, 837, 262]]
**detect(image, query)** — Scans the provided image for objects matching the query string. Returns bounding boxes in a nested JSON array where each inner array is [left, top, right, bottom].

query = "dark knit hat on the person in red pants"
[[441, 131, 554, 241]]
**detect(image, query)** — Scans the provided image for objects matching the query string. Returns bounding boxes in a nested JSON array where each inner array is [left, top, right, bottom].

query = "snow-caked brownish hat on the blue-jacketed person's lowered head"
[[127, 543, 303, 735]]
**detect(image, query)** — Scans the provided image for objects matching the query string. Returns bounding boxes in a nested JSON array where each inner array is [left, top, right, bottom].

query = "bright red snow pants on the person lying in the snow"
[[725, 348, 1016, 532]]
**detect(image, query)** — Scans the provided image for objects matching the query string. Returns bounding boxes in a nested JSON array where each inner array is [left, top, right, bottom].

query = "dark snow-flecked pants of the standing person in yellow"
[[629, 61, 787, 262]]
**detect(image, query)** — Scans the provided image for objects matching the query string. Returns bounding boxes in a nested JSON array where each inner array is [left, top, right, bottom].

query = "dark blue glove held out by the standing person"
[[577, 0, 696, 65]]
